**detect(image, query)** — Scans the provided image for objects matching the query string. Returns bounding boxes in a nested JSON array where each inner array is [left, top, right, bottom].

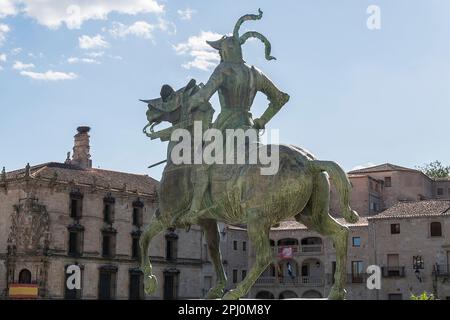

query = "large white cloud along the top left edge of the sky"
[[6, 0, 164, 29]]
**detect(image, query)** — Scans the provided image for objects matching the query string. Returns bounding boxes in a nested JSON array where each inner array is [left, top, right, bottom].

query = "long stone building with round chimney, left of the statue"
[[0, 127, 225, 299]]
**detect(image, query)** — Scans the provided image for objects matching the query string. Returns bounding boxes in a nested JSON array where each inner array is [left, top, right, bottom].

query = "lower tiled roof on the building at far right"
[[369, 200, 450, 220]]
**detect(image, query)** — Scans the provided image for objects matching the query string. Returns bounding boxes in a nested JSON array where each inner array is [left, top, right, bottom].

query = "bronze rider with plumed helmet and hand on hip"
[[178, 9, 289, 222]]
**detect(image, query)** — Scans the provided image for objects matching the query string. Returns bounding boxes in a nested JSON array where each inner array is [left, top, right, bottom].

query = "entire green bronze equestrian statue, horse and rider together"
[[140, 11, 358, 300]]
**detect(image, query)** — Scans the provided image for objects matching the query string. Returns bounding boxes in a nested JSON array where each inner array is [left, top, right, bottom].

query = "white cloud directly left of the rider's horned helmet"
[[173, 31, 222, 71]]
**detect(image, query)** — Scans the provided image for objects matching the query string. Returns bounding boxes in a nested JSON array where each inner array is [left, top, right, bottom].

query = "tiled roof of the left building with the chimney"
[[6, 162, 158, 194]]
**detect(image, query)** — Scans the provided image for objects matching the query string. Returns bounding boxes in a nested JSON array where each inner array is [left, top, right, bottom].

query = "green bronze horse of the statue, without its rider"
[[141, 80, 358, 299]]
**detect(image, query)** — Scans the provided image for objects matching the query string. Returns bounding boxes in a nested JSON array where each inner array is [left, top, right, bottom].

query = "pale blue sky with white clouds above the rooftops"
[[0, 0, 450, 178]]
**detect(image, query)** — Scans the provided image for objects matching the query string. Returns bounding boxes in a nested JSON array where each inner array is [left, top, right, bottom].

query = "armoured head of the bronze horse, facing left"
[[141, 79, 208, 141]]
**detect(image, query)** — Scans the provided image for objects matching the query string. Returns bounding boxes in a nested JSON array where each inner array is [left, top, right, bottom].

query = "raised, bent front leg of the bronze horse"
[[139, 217, 166, 295]]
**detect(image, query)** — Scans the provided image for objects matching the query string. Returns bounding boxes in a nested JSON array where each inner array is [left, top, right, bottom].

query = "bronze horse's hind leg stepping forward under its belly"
[[222, 209, 273, 300]]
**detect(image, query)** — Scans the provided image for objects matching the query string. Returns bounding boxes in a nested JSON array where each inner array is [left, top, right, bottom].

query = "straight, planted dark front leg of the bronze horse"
[[199, 219, 227, 299]]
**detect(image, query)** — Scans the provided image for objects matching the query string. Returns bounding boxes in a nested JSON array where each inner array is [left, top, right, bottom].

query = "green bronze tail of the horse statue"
[[310, 160, 359, 222]]
